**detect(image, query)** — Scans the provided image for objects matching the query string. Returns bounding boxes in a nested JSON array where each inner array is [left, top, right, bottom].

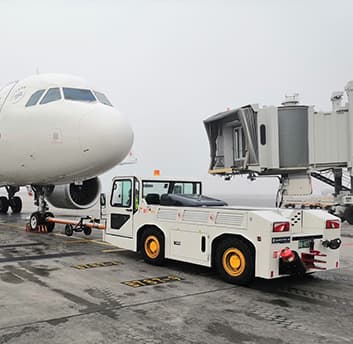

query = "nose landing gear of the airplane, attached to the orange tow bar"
[[28, 186, 55, 233]]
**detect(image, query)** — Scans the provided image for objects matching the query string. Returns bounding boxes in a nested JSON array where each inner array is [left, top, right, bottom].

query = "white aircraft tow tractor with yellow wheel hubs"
[[101, 177, 341, 284]]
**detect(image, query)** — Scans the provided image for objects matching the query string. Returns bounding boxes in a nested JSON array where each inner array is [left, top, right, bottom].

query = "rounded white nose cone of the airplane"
[[79, 106, 133, 170]]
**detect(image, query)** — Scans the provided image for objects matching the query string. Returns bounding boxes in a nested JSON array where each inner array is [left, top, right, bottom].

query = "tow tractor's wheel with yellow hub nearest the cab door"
[[140, 228, 164, 265]]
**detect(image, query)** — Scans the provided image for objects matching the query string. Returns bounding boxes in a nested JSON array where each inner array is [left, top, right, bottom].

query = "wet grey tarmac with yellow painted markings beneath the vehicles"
[[0, 196, 353, 344]]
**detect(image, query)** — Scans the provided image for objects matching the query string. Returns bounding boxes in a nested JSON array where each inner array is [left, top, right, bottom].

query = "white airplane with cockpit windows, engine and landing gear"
[[0, 74, 133, 232]]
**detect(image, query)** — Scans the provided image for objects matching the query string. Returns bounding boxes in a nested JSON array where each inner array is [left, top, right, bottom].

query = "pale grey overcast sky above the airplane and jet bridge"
[[0, 0, 353, 193]]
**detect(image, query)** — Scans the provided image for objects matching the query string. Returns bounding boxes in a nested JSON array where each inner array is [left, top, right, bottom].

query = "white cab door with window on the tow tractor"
[[106, 177, 135, 238]]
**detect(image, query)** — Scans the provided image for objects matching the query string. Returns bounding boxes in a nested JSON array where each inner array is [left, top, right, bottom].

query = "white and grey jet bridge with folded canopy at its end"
[[204, 81, 353, 224]]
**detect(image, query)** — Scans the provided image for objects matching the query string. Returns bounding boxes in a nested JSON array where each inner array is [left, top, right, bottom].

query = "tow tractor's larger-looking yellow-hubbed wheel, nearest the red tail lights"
[[215, 238, 255, 285]]
